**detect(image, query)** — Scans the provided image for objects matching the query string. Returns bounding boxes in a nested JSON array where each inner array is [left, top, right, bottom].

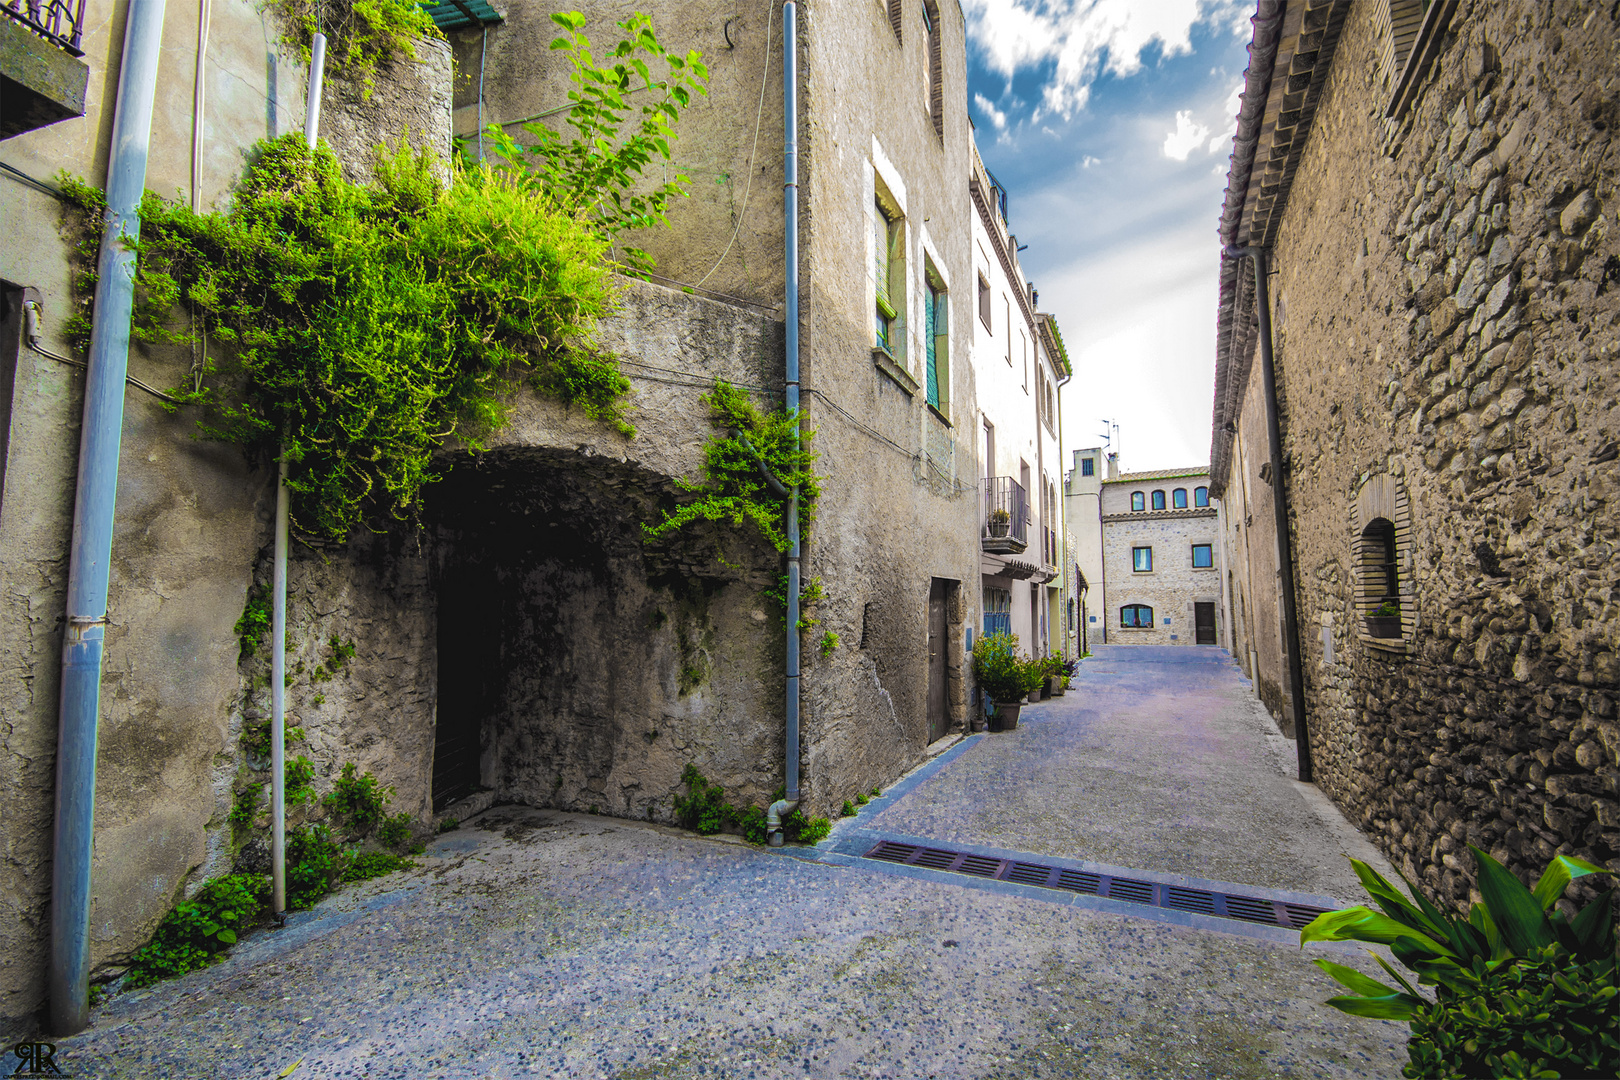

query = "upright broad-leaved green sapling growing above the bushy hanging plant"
[[486, 11, 708, 275]]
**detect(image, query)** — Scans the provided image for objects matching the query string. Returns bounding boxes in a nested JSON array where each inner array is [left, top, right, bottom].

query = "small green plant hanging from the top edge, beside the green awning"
[[272, 0, 441, 99]]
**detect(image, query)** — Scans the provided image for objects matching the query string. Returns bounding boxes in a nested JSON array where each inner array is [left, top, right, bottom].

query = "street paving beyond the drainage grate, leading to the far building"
[[860, 646, 1393, 904]]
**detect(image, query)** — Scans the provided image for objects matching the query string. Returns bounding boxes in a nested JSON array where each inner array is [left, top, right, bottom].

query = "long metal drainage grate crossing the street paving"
[[867, 840, 1328, 929]]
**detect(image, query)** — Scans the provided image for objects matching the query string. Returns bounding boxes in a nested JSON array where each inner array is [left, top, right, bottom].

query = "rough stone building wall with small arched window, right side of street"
[[1212, 0, 1620, 907]]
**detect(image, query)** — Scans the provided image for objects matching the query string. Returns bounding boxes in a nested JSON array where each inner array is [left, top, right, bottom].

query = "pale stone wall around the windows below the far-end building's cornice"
[[1102, 510, 1221, 644]]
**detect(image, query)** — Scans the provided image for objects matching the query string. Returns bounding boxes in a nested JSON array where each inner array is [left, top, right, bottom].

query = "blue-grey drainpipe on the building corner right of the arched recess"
[[765, 0, 799, 847]]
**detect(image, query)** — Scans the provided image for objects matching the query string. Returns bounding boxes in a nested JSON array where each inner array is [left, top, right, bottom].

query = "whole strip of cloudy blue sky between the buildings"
[[962, 0, 1254, 470]]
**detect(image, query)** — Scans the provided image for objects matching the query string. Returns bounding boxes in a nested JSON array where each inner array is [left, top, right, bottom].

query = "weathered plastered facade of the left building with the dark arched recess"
[[0, 0, 978, 1031]]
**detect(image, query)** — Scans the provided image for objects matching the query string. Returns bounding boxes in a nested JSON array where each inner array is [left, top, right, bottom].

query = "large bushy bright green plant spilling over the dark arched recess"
[[60, 134, 633, 541]]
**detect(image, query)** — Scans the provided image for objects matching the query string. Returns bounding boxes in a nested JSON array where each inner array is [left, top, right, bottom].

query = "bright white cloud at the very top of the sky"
[[964, 0, 1252, 120]]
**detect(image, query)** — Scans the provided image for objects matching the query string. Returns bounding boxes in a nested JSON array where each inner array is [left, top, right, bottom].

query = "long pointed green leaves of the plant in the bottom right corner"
[[1299, 847, 1615, 1020]]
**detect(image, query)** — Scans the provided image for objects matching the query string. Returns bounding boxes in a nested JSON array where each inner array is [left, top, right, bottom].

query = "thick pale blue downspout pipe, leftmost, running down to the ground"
[[49, 0, 165, 1035]]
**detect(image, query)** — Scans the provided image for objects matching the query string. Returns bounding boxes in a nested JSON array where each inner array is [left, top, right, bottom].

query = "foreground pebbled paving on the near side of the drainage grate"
[[58, 806, 1405, 1080]]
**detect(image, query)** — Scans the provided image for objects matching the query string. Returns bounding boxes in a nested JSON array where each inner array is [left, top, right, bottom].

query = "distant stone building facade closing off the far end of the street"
[[1098, 468, 1226, 644]]
